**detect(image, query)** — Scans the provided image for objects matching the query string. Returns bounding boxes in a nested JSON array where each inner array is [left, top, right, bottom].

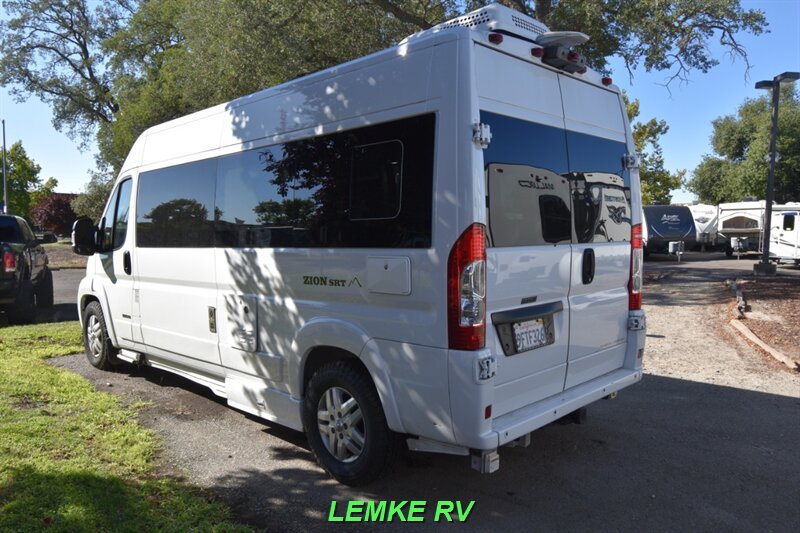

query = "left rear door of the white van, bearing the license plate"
[[475, 45, 572, 416]]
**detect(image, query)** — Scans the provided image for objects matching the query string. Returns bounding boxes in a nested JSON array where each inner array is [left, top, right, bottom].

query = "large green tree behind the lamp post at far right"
[[687, 84, 800, 204]]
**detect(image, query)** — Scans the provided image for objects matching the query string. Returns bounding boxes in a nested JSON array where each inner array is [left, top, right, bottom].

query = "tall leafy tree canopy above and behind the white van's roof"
[[0, 0, 766, 180]]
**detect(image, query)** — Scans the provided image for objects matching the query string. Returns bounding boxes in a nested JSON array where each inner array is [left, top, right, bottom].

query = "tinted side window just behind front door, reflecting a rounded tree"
[[136, 160, 217, 248]]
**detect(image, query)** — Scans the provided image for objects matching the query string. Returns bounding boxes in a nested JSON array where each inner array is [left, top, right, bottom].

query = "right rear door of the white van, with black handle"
[[559, 74, 632, 389]]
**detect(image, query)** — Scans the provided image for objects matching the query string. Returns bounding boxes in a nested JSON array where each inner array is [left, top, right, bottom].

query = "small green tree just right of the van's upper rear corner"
[[622, 93, 686, 205]]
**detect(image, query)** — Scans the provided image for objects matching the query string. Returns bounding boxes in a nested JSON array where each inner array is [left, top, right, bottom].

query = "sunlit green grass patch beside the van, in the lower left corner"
[[0, 322, 250, 532]]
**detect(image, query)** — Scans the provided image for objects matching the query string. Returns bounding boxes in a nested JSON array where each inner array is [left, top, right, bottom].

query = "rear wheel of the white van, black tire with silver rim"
[[303, 361, 400, 486]]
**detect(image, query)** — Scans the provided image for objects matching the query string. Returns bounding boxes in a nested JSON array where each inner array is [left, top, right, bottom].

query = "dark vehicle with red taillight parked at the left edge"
[[0, 215, 53, 324]]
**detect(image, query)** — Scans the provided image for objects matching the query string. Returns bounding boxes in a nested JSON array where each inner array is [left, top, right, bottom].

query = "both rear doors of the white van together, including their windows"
[[476, 45, 631, 416]]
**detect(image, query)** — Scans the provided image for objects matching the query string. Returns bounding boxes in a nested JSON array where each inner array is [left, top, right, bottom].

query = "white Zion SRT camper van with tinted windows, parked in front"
[[73, 5, 645, 485]]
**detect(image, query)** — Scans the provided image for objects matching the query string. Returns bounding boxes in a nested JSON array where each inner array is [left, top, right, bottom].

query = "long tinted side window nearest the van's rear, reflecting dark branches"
[[215, 114, 435, 248]]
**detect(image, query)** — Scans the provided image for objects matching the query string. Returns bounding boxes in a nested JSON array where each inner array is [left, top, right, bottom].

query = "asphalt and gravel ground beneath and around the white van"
[[55, 261, 800, 532]]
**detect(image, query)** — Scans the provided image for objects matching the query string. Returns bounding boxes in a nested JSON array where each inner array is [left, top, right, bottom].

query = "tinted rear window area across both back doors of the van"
[[481, 111, 631, 247]]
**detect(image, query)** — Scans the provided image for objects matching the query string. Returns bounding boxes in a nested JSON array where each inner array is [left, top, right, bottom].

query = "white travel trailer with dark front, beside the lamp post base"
[[717, 200, 800, 257]]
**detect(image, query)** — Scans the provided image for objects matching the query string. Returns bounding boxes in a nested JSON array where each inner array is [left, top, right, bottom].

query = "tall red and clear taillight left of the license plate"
[[447, 223, 486, 350]]
